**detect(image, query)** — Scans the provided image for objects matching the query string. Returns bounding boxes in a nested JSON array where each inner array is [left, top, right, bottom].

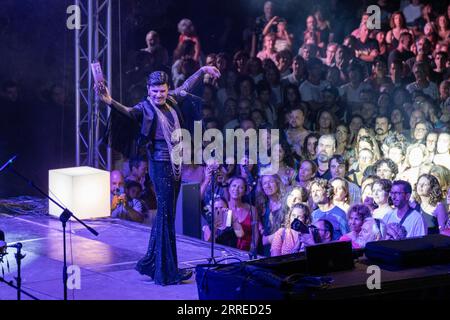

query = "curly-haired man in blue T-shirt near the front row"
[[310, 178, 349, 240]]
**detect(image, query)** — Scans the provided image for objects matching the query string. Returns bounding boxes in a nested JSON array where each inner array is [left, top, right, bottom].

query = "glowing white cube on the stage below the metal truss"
[[48, 167, 111, 219]]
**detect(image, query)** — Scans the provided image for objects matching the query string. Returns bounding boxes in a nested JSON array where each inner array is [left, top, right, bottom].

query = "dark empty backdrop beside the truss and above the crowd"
[[0, 0, 446, 196]]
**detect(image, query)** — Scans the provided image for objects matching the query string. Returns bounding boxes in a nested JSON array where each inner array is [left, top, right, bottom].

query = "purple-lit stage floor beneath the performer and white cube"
[[0, 213, 248, 300]]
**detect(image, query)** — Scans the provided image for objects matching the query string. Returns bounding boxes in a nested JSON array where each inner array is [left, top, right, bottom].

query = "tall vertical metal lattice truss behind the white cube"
[[75, 0, 112, 170]]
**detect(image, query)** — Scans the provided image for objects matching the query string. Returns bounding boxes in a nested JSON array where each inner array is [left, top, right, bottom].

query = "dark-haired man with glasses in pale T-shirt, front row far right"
[[383, 180, 427, 238]]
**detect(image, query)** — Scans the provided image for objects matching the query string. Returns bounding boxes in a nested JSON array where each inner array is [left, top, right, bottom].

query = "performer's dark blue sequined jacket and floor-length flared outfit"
[[105, 69, 203, 285]]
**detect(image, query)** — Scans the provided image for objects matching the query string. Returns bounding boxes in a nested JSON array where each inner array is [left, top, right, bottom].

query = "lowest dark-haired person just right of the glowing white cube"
[[111, 181, 146, 222]]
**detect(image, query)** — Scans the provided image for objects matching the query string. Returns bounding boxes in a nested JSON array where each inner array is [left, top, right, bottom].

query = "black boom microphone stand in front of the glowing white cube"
[[5, 166, 98, 300]]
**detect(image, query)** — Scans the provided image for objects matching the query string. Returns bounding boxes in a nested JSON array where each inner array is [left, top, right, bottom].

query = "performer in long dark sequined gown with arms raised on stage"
[[96, 66, 220, 285]]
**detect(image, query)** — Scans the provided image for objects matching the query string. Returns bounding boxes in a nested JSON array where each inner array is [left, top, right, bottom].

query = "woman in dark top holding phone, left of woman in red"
[[203, 197, 244, 248]]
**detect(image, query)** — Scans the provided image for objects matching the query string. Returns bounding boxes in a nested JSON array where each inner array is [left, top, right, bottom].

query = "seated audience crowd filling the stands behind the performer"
[[106, 0, 450, 256]]
